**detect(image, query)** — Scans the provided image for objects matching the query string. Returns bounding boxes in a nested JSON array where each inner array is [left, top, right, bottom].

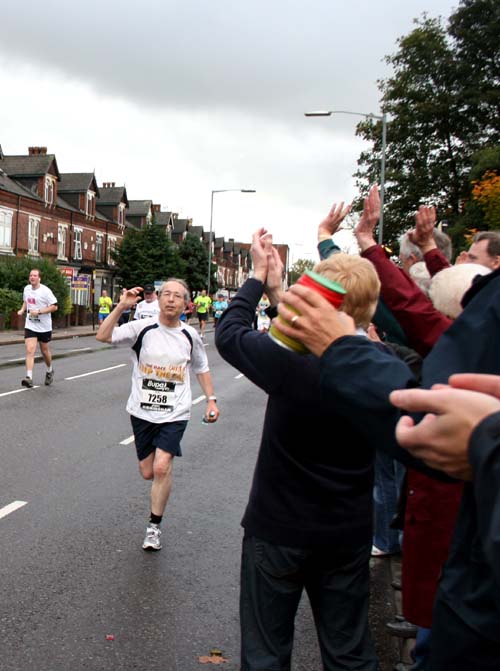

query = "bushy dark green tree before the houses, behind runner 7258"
[[113, 224, 184, 287]]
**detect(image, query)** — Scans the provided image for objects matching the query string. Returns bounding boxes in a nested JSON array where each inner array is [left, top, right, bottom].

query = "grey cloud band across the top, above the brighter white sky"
[[0, 0, 458, 115]]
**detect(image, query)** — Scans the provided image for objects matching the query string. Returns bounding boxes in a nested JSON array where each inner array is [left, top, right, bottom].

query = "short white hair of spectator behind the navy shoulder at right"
[[429, 263, 491, 319]]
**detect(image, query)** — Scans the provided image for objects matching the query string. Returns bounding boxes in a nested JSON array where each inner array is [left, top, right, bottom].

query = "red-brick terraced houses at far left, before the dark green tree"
[[0, 147, 126, 322]]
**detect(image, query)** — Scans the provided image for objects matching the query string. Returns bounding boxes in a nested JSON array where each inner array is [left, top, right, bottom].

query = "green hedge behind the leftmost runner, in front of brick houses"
[[0, 256, 71, 315]]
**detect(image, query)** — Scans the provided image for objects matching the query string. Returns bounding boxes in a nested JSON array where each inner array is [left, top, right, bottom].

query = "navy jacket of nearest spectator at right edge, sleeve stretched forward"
[[321, 270, 500, 648]]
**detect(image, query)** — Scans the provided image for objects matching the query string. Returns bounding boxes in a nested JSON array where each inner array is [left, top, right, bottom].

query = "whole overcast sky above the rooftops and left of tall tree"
[[0, 0, 458, 260]]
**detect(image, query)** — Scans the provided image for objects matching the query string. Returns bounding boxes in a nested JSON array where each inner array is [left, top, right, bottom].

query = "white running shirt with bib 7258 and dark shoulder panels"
[[111, 317, 209, 424]]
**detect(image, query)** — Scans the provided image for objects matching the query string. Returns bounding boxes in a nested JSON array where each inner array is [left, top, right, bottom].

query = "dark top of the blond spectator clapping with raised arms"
[[215, 279, 374, 548]]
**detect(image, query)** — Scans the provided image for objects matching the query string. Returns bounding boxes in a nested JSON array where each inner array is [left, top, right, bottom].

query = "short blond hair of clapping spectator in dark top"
[[314, 252, 380, 330]]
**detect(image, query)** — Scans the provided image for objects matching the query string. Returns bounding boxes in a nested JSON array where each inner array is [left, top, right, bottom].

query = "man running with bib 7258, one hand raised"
[[96, 278, 219, 550]]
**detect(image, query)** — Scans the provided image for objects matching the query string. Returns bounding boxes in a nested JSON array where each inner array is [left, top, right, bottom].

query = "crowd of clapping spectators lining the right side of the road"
[[216, 185, 500, 671]]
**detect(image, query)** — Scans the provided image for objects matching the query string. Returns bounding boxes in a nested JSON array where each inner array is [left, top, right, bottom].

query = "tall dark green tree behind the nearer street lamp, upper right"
[[356, 0, 500, 244]]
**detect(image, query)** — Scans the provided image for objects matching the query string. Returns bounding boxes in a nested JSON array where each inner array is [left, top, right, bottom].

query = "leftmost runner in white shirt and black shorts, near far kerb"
[[17, 268, 57, 388]]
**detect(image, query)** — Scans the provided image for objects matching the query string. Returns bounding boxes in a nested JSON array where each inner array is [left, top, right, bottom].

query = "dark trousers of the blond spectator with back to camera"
[[240, 537, 377, 671]]
